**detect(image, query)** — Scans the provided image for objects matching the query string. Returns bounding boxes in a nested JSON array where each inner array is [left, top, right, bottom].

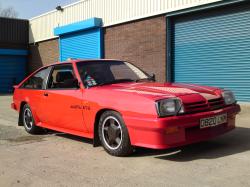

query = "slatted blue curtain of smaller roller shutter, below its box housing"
[[60, 28, 102, 61]]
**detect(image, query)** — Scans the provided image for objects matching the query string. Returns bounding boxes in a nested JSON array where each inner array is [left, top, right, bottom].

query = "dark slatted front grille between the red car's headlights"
[[184, 97, 225, 114]]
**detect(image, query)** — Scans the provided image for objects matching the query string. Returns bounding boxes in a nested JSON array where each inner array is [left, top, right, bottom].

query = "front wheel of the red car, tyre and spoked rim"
[[98, 111, 133, 156]]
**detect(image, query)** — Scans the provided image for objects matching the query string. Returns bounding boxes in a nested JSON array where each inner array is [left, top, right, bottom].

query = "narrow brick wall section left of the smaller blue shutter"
[[28, 39, 59, 73]]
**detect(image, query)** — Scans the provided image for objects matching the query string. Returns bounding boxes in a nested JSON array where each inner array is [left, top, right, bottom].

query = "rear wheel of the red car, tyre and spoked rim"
[[21, 104, 44, 134]]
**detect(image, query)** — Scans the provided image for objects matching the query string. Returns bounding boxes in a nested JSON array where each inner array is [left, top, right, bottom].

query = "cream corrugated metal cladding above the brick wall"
[[29, 0, 220, 43]]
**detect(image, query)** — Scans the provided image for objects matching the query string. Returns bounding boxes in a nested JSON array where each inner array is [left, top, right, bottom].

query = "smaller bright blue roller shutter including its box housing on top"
[[54, 17, 103, 61]]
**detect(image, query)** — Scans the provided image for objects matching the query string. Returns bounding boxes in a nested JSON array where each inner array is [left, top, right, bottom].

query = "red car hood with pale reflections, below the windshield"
[[96, 82, 222, 99]]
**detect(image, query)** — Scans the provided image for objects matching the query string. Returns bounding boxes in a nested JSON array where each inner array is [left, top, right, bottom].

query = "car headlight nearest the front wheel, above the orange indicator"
[[156, 98, 184, 117]]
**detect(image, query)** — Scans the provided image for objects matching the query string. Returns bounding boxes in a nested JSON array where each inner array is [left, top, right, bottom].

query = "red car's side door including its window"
[[38, 64, 87, 132]]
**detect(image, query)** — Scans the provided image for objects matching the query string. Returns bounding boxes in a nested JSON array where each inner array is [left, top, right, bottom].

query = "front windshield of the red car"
[[77, 60, 151, 87]]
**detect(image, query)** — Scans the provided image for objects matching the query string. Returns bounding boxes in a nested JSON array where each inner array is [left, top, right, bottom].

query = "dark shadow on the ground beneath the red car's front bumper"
[[132, 127, 250, 162]]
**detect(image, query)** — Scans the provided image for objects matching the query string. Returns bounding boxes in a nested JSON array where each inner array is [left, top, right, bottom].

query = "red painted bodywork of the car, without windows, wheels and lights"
[[11, 60, 240, 149]]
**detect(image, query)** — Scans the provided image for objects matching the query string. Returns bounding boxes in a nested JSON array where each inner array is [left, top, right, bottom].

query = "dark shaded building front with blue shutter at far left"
[[0, 18, 29, 93]]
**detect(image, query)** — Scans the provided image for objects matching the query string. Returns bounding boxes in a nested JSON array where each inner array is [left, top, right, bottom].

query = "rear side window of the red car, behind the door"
[[21, 67, 51, 90]]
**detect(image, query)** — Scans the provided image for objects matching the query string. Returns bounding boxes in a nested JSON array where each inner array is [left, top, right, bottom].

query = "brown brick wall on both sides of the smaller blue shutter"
[[28, 16, 166, 82]]
